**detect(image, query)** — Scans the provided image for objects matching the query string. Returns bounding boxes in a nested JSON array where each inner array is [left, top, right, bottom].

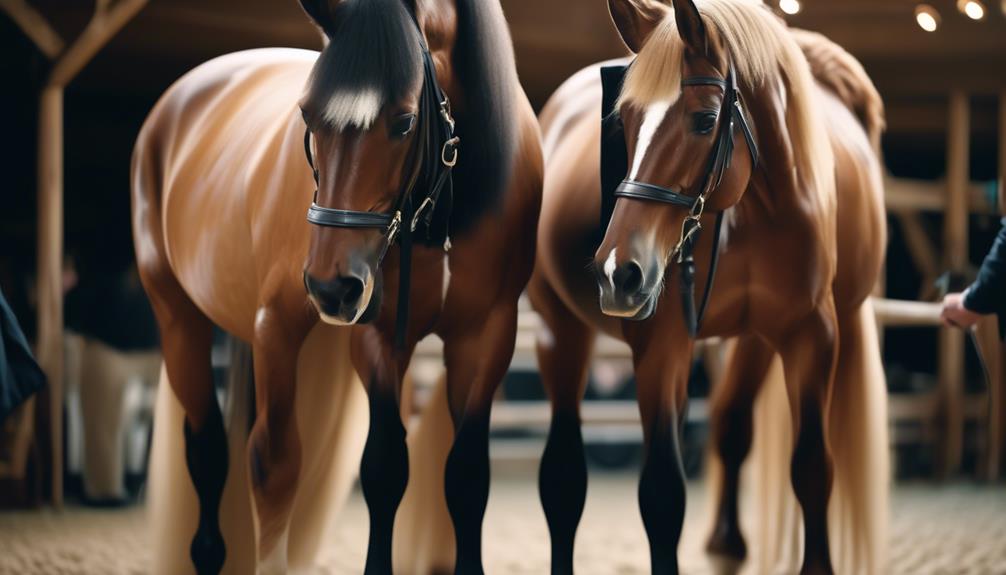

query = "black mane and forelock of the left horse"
[[302, 0, 519, 233]]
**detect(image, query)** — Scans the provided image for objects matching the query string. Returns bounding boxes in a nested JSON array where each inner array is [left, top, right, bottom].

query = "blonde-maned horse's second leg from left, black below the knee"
[[633, 337, 691, 575]]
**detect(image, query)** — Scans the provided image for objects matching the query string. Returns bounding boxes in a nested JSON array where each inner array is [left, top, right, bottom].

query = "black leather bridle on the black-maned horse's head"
[[304, 24, 461, 351]]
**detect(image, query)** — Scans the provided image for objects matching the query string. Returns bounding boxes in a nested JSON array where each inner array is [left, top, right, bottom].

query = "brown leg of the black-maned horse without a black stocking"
[[247, 303, 312, 574]]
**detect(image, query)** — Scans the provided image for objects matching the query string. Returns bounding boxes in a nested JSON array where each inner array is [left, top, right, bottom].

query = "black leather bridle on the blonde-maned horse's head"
[[615, 64, 759, 338]]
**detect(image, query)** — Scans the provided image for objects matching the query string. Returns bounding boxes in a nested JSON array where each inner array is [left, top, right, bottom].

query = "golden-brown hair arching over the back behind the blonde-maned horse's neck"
[[790, 28, 886, 156]]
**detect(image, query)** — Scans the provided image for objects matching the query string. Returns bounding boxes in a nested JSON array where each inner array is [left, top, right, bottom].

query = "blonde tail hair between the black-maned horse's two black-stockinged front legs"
[[393, 376, 455, 574]]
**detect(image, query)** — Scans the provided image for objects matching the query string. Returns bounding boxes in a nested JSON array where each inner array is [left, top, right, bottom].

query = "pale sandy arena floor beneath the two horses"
[[0, 472, 1006, 575]]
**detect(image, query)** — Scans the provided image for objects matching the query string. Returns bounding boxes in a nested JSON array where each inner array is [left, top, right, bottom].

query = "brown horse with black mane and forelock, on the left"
[[132, 0, 543, 574]]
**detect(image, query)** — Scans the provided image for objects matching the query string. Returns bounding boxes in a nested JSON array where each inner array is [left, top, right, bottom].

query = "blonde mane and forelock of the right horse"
[[619, 0, 835, 222]]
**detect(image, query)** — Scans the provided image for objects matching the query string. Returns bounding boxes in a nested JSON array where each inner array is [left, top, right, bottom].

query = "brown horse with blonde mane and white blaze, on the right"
[[529, 0, 887, 573]]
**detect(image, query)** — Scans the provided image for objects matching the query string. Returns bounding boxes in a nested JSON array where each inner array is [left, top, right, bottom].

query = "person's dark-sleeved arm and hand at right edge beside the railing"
[[940, 218, 1006, 336]]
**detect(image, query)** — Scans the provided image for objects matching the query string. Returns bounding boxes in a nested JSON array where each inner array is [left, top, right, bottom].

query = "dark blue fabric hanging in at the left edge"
[[0, 292, 45, 422]]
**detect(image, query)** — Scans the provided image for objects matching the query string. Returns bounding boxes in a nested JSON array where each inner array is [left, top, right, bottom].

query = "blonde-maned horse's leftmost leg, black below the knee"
[[529, 277, 595, 575]]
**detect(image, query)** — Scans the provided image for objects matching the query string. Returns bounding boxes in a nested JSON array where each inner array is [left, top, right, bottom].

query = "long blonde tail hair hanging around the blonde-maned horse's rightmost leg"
[[750, 300, 890, 574]]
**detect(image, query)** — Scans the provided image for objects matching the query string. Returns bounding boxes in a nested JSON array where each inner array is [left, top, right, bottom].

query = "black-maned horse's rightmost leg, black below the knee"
[[444, 302, 517, 575]]
